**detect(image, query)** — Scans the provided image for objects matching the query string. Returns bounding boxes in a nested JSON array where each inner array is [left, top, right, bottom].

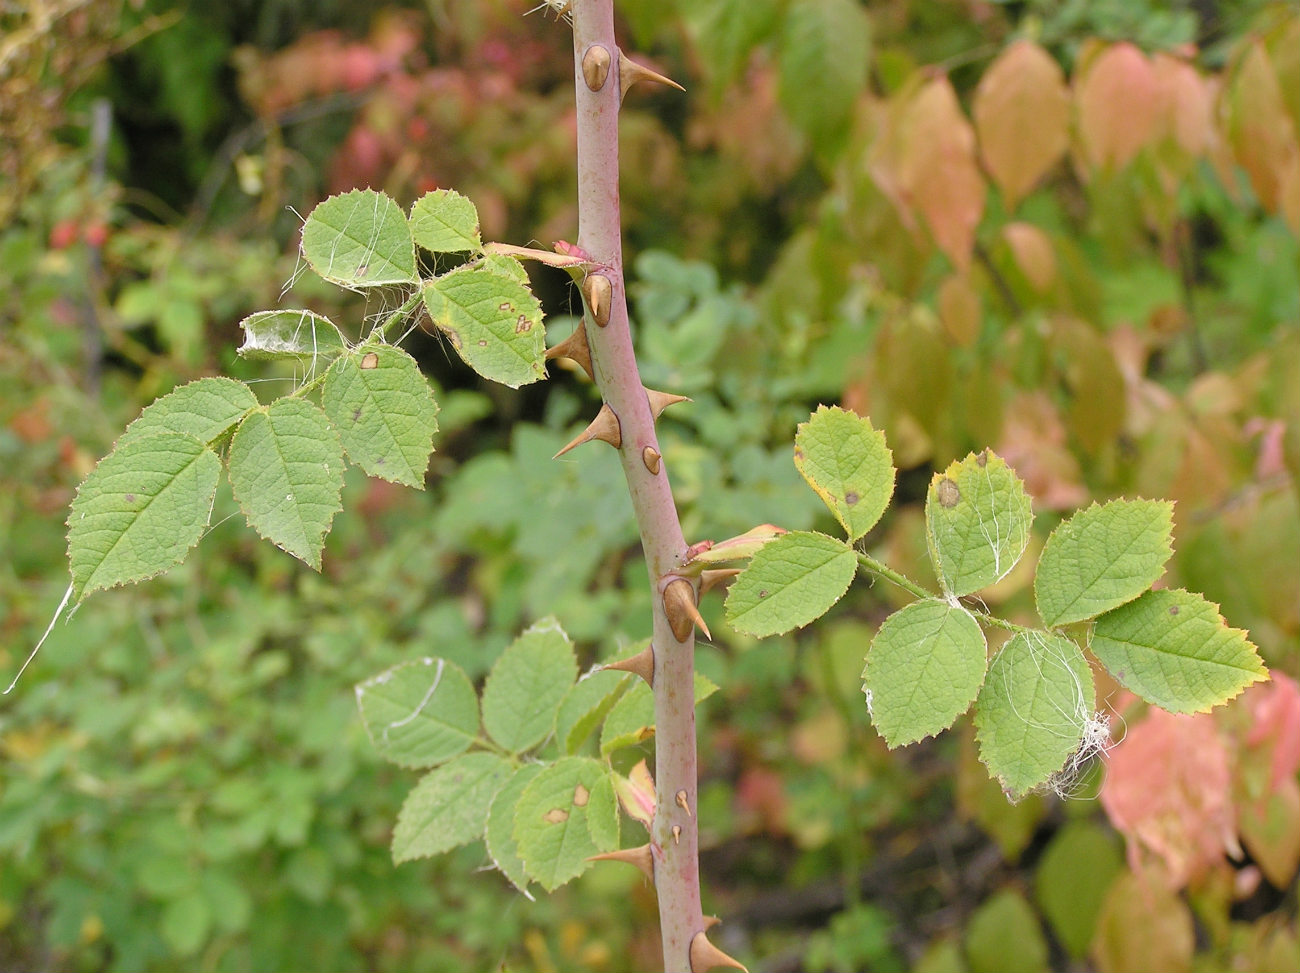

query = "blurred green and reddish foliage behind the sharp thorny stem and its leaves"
[[0, 0, 1300, 972]]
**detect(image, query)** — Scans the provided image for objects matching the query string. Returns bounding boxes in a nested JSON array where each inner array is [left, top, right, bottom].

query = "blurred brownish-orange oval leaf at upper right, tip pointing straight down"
[[972, 40, 1070, 211]]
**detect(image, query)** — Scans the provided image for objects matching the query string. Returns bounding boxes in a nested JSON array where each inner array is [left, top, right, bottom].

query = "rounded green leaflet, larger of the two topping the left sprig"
[[303, 189, 416, 287]]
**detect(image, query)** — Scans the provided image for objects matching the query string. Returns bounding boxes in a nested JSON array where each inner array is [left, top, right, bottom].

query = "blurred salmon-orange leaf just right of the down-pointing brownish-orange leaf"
[[1074, 43, 1162, 169]]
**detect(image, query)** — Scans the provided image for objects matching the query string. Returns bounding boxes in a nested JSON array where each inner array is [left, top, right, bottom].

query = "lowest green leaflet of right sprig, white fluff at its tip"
[[975, 632, 1096, 797]]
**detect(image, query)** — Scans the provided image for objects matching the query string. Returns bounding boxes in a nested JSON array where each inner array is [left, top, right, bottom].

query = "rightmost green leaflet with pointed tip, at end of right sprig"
[[1088, 589, 1269, 713]]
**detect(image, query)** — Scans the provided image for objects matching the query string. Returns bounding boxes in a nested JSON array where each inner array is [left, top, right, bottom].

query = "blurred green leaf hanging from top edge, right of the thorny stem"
[[779, 0, 870, 157]]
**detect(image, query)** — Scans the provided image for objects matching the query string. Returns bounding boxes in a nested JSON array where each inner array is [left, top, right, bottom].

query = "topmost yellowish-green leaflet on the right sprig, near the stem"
[[794, 406, 894, 541]]
